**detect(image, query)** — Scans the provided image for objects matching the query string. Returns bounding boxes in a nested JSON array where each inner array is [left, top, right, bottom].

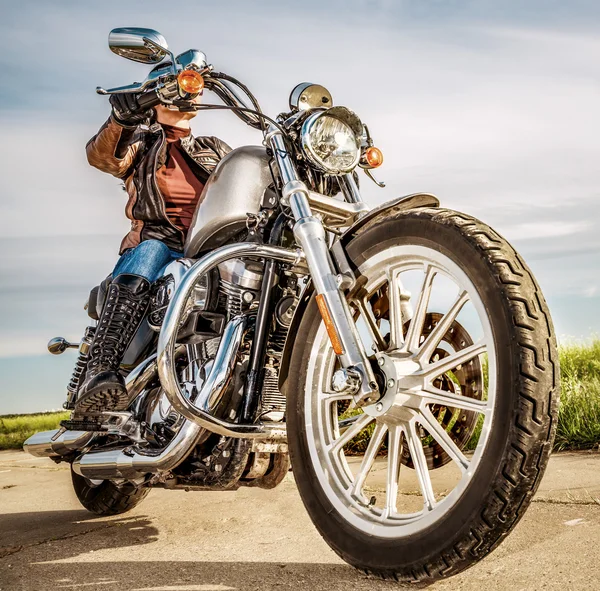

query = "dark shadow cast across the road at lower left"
[[0, 511, 408, 591]]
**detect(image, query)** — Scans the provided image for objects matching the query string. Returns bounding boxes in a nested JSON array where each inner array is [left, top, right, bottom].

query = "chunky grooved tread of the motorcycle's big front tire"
[[286, 208, 560, 583]]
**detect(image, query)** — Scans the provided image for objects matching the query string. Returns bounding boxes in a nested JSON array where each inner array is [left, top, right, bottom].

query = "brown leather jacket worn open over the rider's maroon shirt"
[[85, 116, 231, 253]]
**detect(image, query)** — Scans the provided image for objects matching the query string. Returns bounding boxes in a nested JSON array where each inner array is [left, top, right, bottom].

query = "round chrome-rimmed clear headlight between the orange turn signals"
[[301, 111, 360, 174]]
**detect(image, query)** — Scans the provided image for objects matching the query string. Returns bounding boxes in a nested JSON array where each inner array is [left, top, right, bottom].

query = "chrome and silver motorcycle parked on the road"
[[24, 28, 559, 582]]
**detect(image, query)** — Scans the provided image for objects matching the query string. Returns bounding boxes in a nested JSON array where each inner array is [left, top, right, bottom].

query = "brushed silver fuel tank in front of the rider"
[[184, 146, 274, 257]]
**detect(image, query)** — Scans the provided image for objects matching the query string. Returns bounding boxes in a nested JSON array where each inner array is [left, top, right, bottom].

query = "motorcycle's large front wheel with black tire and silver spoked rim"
[[284, 209, 559, 582]]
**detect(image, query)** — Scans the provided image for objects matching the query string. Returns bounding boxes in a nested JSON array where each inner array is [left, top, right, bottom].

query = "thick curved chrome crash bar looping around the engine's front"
[[157, 243, 304, 439]]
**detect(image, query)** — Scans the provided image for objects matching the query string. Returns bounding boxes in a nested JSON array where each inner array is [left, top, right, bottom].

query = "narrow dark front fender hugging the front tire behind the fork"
[[279, 193, 440, 392]]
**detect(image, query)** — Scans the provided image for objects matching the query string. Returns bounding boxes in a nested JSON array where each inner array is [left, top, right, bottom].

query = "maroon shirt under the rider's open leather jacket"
[[156, 125, 204, 234]]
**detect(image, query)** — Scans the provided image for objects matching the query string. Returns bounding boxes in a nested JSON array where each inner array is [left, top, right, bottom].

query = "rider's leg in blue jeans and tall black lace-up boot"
[[75, 240, 182, 414]]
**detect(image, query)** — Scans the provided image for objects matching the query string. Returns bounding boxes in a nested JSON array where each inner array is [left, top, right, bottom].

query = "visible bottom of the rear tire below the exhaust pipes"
[[71, 468, 150, 515]]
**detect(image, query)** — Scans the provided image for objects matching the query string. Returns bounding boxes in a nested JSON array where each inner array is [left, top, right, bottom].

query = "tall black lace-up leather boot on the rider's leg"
[[75, 274, 150, 416]]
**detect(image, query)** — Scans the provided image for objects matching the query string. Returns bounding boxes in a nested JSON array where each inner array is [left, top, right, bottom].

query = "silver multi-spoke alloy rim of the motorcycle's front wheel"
[[305, 245, 496, 538]]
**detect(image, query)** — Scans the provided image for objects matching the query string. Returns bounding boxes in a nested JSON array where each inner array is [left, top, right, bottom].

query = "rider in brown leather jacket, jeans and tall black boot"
[[75, 71, 231, 414]]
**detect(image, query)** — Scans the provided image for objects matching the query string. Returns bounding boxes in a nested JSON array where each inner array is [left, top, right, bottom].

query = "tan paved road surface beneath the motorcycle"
[[0, 452, 600, 591]]
